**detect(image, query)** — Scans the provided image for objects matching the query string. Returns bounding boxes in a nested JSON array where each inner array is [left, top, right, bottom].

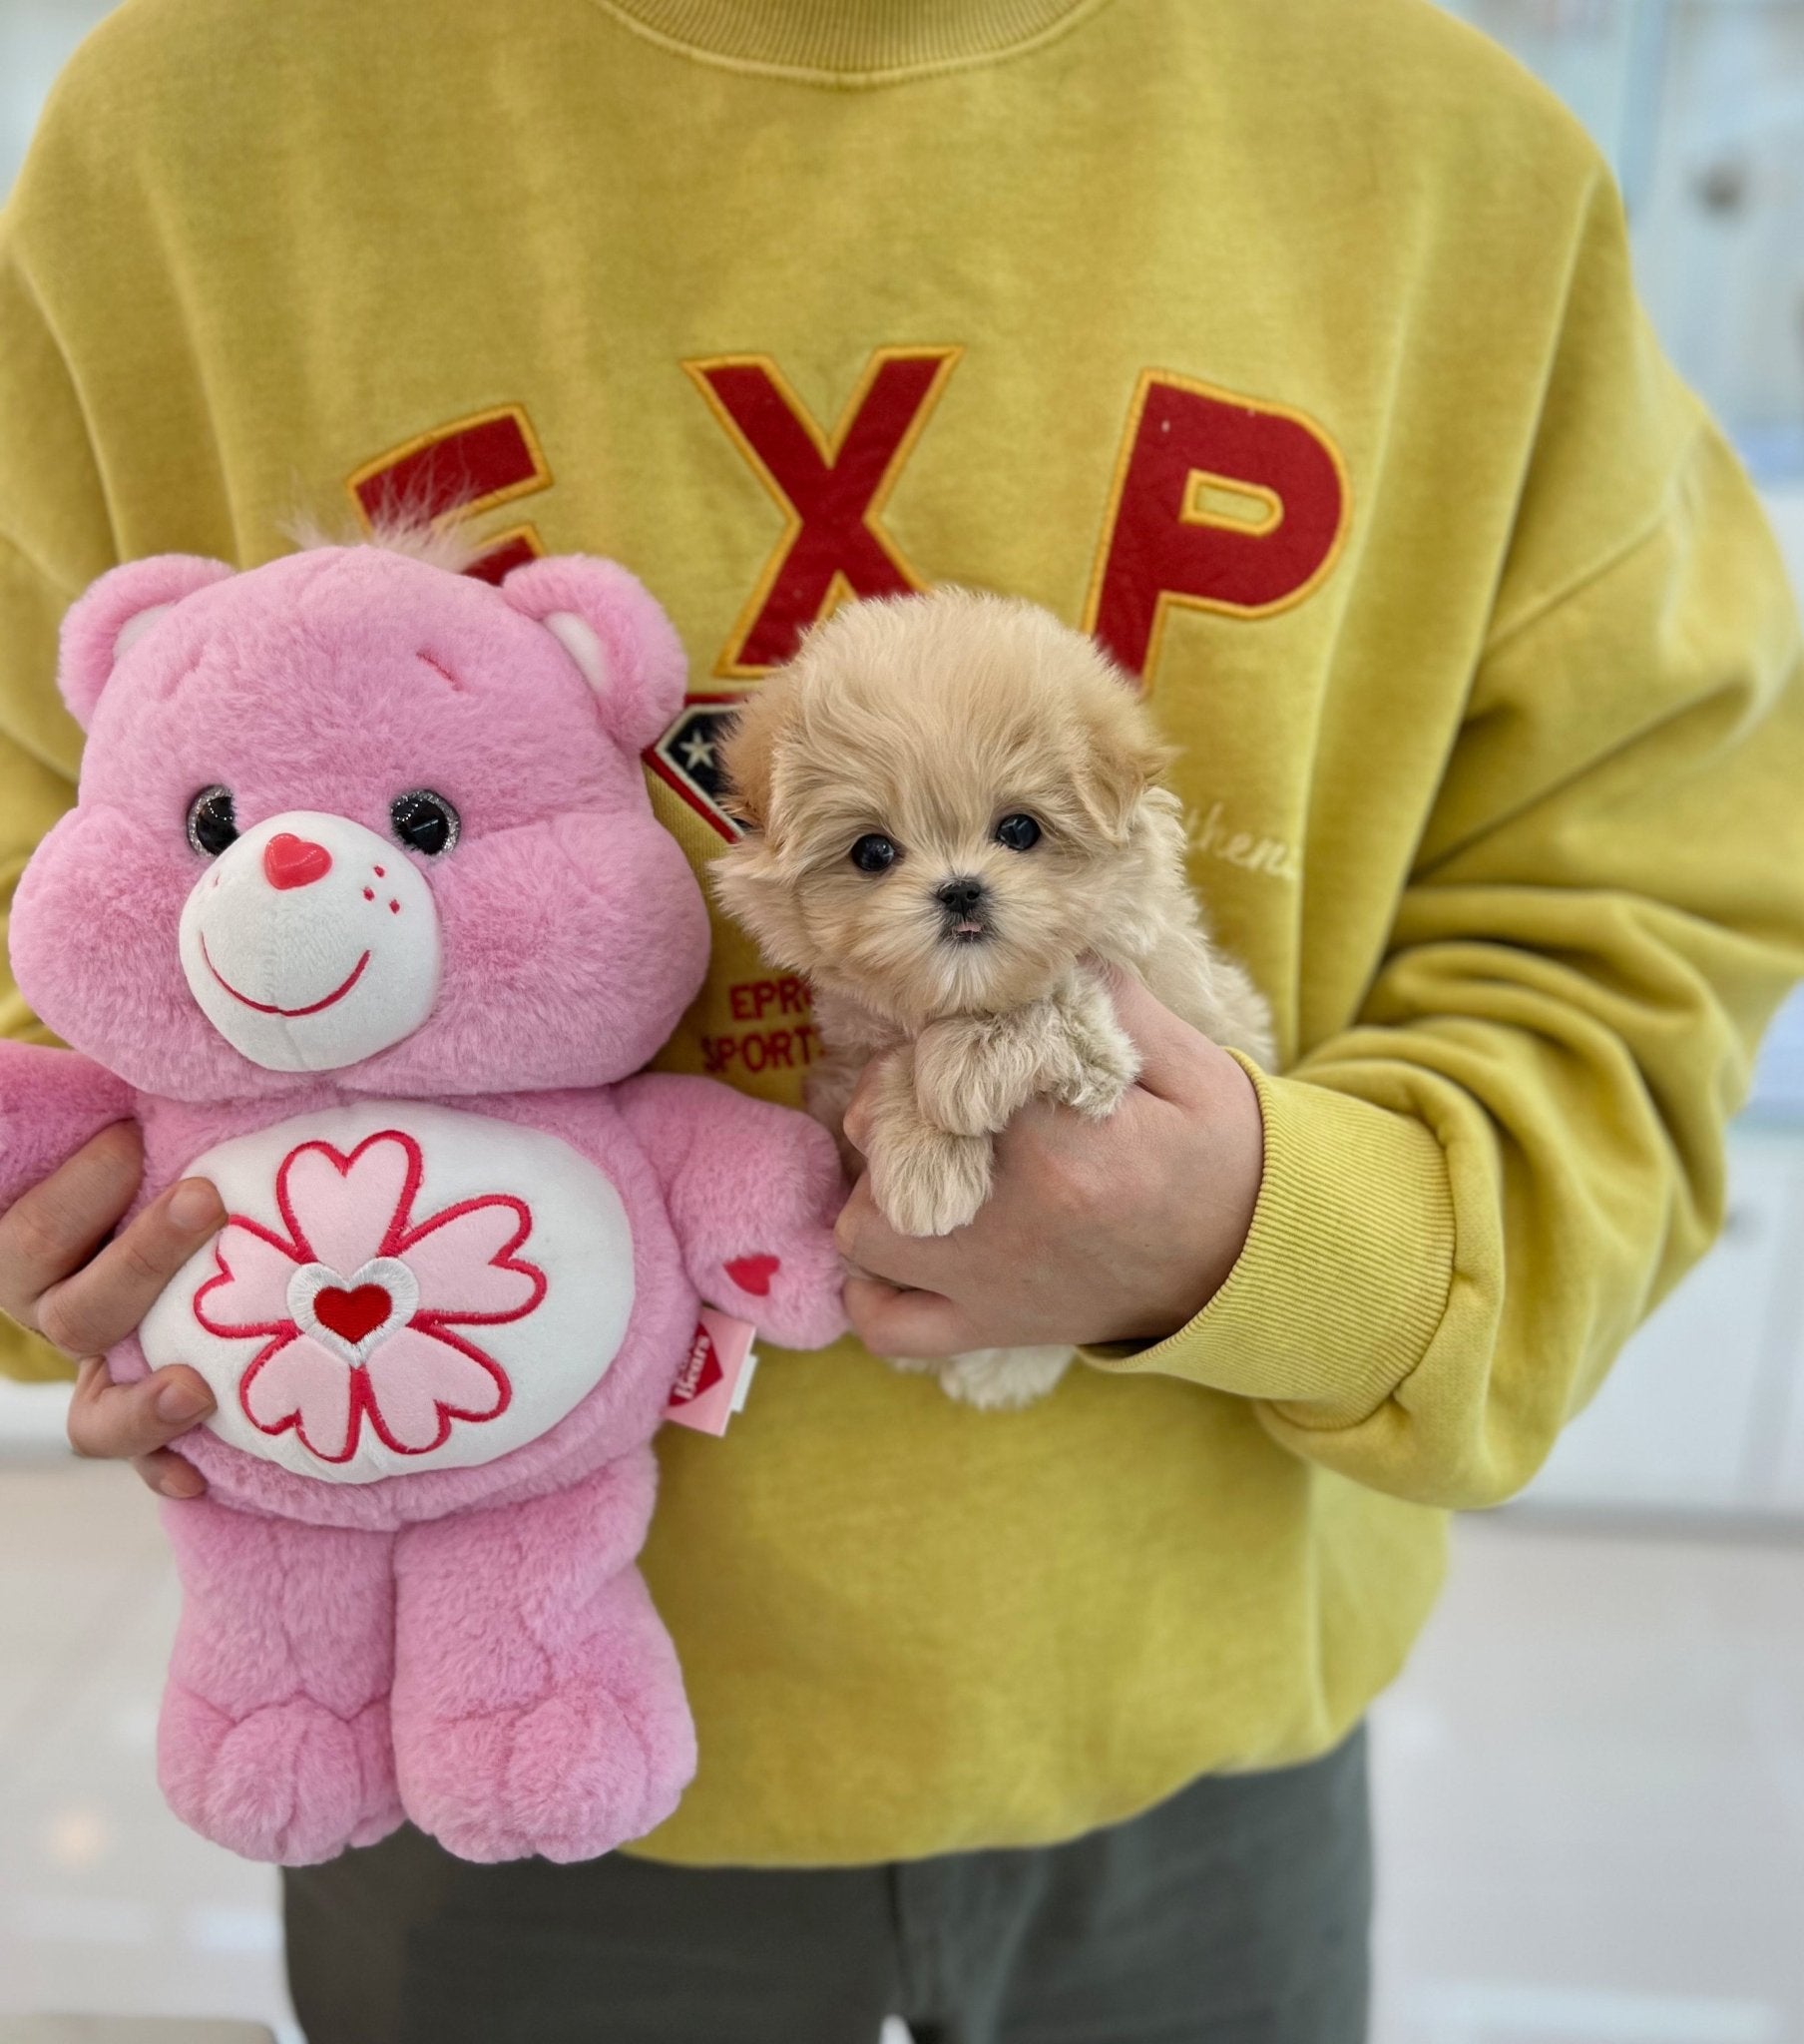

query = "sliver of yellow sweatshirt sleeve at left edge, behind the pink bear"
[[0, 211, 115, 1377]]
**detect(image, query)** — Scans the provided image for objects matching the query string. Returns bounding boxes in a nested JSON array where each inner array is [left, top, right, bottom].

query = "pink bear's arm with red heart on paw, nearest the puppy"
[[615, 1071, 846, 1349]]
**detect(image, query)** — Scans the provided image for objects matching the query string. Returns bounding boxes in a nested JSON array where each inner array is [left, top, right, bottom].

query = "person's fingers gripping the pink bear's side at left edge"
[[0, 1122, 225, 1498]]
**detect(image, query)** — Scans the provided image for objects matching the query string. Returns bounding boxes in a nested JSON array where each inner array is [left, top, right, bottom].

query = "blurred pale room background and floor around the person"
[[0, 0, 1804, 2044]]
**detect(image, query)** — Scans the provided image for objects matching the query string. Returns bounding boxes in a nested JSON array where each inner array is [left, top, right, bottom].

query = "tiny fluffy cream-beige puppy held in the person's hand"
[[713, 589, 1273, 1404]]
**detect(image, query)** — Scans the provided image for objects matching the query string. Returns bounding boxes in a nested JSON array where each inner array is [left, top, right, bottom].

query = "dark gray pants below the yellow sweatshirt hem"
[[284, 1734, 1371, 2044]]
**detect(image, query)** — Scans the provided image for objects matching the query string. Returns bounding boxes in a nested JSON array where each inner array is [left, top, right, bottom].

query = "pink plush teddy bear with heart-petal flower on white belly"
[[0, 546, 844, 1864]]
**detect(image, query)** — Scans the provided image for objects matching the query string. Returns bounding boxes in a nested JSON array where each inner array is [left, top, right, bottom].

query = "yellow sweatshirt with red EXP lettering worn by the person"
[[0, 0, 1804, 1864]]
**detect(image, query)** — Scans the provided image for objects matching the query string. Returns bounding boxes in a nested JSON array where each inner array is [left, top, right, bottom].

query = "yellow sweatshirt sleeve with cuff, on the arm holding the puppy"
[[1091, 199, 1804, 1506]]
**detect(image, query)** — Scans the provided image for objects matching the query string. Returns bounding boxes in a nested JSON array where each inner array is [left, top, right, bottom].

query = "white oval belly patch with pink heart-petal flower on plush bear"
[[141, 1102, 634, 1484]]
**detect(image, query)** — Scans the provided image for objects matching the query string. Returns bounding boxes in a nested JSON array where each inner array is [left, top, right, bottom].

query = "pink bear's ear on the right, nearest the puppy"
[[501, 554, 688, 753]]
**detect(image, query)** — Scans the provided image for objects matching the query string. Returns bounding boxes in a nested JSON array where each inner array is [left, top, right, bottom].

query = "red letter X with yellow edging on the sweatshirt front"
[[682, 347, 962, 677]]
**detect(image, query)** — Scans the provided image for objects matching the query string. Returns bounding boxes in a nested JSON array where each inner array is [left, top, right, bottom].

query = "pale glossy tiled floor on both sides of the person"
[[0, 1406, 1804, 2044]]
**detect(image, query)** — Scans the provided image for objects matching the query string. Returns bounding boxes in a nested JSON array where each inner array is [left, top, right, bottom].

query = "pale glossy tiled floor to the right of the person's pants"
[[1375, 1517, 1804, 2044]]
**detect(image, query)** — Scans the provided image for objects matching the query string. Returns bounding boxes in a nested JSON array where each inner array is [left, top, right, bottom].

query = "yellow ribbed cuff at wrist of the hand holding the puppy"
[[1083, 1059, 1453, 1427]]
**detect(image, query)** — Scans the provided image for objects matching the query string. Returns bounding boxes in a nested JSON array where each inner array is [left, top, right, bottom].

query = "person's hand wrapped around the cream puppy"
[[835, 975, 1264, 1361]]
